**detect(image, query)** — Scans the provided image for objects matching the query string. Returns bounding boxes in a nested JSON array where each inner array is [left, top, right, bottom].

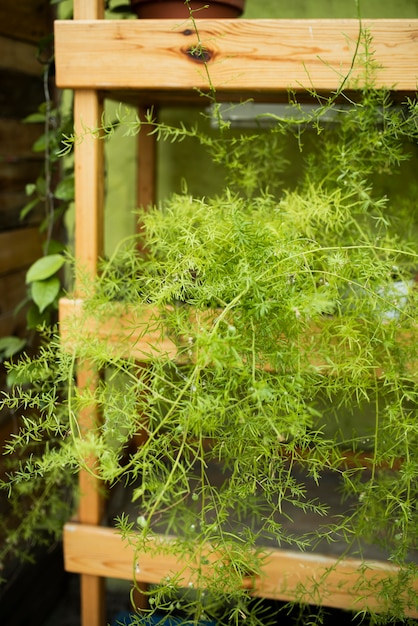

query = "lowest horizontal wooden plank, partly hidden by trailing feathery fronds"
[[64, 523, 418, 617]]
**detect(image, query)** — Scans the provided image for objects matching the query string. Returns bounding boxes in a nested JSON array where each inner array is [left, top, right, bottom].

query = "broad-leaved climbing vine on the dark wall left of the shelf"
[[0, 22, 74, 360]]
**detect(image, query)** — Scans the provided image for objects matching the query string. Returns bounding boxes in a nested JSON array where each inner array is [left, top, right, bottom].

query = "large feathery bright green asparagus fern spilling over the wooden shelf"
[[3, 15, 418, 624]]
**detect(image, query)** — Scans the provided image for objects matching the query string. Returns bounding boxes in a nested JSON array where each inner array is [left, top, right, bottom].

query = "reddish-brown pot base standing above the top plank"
[[131, 0, 245, 19]]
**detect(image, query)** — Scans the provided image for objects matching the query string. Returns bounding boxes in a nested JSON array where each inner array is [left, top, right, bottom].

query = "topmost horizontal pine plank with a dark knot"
[[55, 19, 418, 95]]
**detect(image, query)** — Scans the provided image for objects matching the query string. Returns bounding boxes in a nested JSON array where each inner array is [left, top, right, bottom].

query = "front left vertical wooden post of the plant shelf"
[[73, 0, 105, 626]]
